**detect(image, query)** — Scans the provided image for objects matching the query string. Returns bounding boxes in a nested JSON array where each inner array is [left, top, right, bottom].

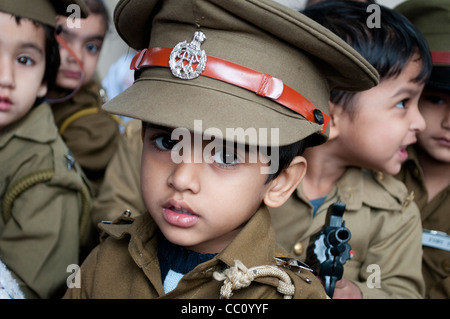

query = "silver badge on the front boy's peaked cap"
[[169, 31, 206, 80]]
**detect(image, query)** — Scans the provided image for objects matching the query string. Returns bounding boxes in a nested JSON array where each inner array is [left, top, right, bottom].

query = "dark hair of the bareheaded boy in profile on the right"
[[302, 1, 432, 114]]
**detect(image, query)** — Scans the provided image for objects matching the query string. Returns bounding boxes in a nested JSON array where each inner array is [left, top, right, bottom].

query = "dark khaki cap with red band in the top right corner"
[[395, 0, 450, 91]]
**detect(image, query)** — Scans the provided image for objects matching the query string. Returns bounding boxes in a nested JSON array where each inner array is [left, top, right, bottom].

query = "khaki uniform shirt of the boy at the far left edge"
[[0, 104, 91, 298]]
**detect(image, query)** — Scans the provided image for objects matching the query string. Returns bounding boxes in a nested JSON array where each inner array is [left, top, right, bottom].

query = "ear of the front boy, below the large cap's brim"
[[264, 156, 306, 207]]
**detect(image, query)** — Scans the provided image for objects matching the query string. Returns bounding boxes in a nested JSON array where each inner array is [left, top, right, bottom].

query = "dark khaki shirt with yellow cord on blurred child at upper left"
[[52, 82, 120, 194]]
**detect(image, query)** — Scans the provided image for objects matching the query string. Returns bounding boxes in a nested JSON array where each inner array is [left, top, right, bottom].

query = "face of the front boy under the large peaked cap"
[[141, 127, 282, 253]]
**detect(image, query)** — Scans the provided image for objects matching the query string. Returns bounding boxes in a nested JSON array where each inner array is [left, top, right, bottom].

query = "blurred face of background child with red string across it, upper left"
[[56, 14, 106, 90]]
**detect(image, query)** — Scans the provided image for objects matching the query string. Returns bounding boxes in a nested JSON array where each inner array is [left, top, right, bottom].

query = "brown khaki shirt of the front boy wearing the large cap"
[[64, 208, 326, 299]]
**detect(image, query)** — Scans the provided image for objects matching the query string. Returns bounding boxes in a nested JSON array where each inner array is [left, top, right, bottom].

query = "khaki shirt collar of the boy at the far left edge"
[[0, 103, 58, 148]]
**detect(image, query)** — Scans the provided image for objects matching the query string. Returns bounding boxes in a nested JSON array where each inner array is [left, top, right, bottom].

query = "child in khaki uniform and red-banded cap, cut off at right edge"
[[395, 0, 450, 299]]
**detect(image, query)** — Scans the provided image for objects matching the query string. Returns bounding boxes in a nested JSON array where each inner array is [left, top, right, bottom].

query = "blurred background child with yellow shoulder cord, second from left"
[[49, 0, 120, 196]]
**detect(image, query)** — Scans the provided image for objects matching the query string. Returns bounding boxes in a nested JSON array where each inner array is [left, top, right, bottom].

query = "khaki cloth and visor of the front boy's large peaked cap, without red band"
[[103, 0, 379, 146]]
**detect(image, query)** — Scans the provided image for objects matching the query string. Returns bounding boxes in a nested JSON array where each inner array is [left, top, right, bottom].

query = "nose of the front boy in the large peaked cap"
[[168, 161, 202, 194]]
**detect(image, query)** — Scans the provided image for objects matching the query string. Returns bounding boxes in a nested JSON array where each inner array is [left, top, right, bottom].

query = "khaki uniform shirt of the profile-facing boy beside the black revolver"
[[270, 168, 424, 298]]
